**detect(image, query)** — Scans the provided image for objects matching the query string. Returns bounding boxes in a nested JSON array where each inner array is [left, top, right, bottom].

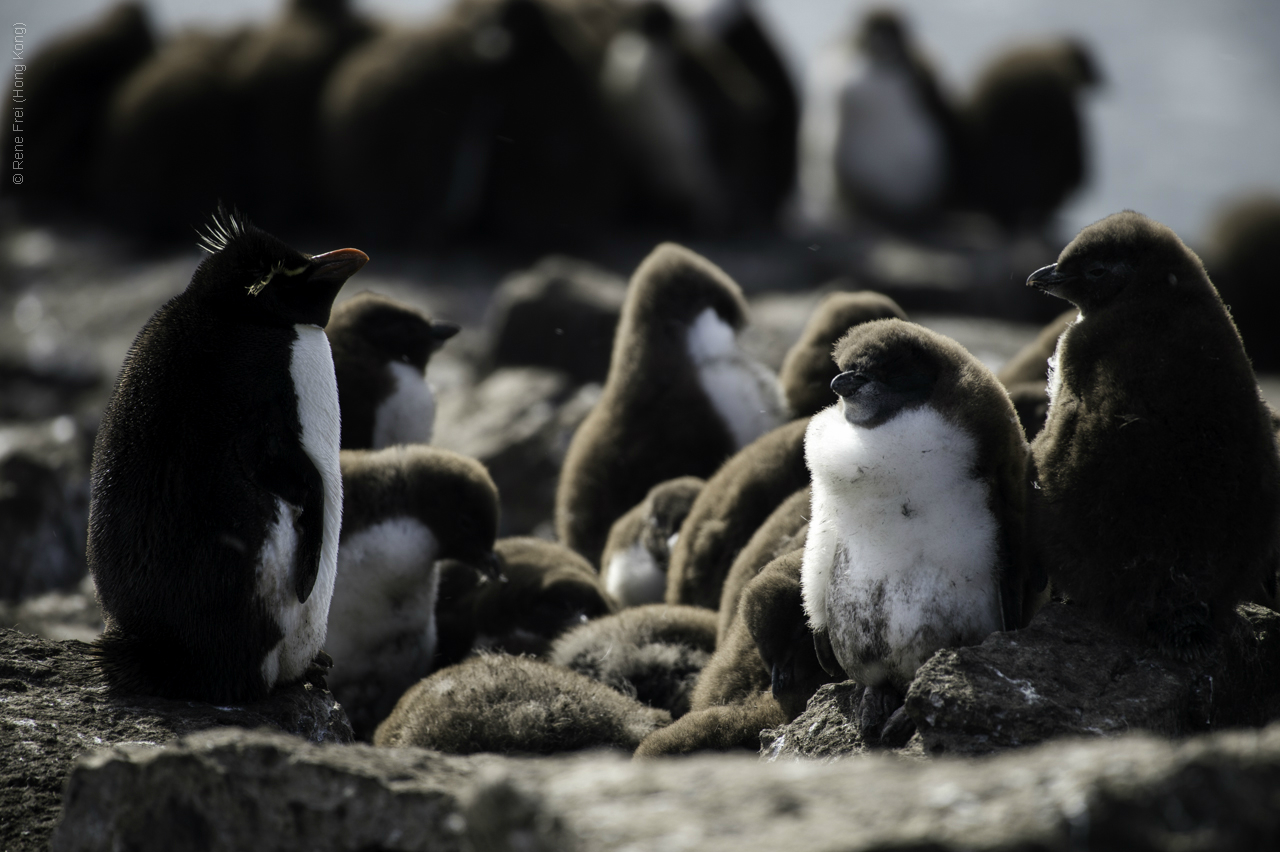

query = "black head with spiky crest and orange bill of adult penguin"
[[187, 207, 369, 327]]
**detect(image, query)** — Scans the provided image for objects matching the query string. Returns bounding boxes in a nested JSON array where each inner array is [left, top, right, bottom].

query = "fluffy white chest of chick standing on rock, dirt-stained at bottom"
[[801, 404, 1001, 687]]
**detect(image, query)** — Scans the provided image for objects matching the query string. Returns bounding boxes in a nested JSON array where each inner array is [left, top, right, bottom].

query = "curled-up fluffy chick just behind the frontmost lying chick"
[[547, 604, 716, 719]]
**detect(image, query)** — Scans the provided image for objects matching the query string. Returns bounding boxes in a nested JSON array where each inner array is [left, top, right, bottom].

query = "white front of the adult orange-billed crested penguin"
[[257, 325, 342, 686]]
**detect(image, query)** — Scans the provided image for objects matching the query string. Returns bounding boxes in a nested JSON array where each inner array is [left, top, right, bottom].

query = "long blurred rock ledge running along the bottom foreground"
[[52, 725, 1280, 852]]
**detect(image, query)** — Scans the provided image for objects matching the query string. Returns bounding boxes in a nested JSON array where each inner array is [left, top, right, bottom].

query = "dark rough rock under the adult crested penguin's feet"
[[0, 629, 352, 852]]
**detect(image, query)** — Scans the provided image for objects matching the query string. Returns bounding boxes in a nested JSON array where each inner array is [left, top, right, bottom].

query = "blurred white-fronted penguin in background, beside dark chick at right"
[[800, 9, 957, 228]]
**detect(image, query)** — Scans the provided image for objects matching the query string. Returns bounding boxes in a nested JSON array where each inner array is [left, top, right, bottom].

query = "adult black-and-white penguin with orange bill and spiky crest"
[[87, 210, 369, 704]]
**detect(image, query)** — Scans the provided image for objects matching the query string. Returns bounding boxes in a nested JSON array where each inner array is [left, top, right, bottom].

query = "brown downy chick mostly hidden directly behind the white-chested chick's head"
[[778, 290, 906, 417]]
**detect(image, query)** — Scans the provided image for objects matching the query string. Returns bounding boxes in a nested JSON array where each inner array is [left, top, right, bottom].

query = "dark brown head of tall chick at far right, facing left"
[[1027, 210, 1208, 317]]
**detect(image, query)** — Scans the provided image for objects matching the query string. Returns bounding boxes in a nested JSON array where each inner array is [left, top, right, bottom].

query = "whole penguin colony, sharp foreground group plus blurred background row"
[[33, 0, 1280, 756]]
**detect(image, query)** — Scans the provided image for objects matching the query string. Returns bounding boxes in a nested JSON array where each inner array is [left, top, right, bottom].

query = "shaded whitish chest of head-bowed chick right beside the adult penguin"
[[325, 517, 439, 690]]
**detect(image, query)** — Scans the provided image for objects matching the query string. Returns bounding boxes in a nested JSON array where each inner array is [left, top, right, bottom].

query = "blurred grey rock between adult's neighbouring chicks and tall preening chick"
[[434, 367, 600, 536]]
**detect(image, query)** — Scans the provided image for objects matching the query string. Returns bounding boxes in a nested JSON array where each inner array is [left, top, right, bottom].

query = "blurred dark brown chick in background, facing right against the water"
[[963, 38, 1101, 230]]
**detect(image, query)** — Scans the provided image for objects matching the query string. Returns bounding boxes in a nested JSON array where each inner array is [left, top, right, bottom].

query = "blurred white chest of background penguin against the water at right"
[[836, 63, 947, 214]]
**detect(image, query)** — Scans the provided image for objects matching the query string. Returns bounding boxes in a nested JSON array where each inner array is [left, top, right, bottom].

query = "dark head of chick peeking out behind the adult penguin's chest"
[[325, 292, 458, 370]]
